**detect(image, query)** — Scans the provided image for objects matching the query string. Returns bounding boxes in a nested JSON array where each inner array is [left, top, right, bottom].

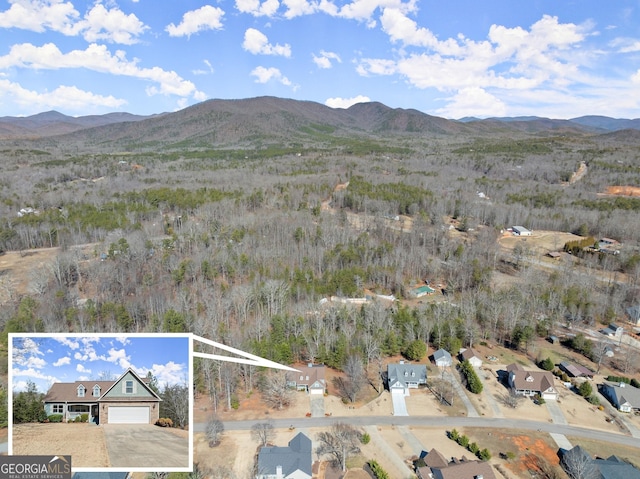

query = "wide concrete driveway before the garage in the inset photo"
[[101, 424, 190, 470]]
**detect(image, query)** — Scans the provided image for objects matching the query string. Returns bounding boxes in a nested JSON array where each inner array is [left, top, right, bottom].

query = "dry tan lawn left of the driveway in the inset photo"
[[12, 423, 109, 467]]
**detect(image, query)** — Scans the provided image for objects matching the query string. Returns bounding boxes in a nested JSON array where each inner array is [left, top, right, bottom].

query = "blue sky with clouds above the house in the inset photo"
[[11, 334, 190, 393]]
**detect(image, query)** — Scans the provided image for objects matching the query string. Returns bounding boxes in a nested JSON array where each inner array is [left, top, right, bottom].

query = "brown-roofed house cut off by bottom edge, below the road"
[[416, 449, 496, 479]]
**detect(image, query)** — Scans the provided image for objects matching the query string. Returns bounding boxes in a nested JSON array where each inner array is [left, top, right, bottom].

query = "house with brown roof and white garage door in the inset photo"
[[44, 368, 162, 424]]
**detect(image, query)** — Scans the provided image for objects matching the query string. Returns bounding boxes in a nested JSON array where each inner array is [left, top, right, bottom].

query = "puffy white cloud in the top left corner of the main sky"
[[0, 0, 149, 45]]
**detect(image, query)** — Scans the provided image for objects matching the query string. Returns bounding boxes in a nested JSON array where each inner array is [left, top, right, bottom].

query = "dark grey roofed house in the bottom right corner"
[[560, 446, 640, 479]]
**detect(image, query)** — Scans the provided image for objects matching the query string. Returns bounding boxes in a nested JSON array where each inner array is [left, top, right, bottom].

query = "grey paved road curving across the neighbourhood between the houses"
[[193, 416, 640, 447]]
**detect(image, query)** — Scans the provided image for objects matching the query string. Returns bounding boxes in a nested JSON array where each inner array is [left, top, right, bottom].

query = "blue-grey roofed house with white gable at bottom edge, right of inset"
[[256, 433, 313, 479]]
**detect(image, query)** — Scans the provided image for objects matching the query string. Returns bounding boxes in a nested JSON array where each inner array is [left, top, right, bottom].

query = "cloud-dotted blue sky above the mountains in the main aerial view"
[[0, 0, 640, 118]]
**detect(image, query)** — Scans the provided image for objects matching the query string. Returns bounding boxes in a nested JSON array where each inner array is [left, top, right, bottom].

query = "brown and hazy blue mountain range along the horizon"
[[0, 97, 640, 147]]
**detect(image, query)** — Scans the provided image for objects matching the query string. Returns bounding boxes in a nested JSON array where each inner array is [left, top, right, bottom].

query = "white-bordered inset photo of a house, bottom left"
[[9, 333, 193, 472]]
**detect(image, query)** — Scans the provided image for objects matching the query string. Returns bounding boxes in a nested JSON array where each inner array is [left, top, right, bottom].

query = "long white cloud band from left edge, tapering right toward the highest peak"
[[0, 43, 203, 99]]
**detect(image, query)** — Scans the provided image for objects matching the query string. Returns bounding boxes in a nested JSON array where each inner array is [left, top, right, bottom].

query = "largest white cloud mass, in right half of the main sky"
[[357, 13, 588, 91]]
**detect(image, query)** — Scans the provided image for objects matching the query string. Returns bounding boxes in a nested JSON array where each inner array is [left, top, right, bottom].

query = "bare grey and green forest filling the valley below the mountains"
[[0, 101, 640, 404]]
